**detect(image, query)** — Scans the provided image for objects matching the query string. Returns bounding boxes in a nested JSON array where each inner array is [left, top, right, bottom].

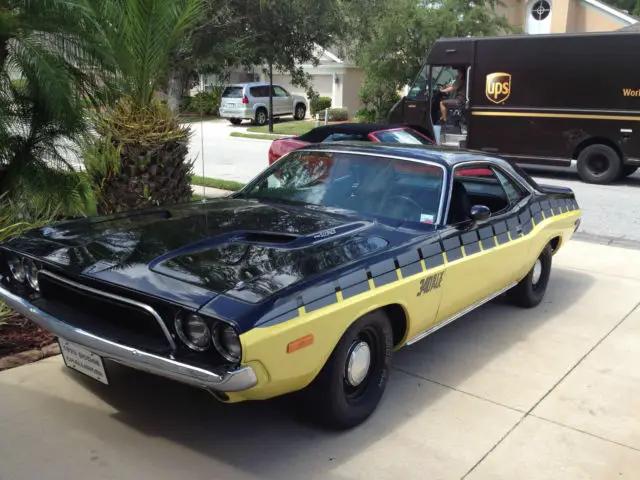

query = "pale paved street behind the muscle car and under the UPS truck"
[[191, 121, 640, 245]]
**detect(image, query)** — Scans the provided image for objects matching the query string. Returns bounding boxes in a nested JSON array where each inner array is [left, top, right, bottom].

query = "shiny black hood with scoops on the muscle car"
[[6, 198, 424, 306]]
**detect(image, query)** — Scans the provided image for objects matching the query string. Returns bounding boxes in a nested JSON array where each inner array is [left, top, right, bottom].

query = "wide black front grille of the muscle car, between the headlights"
[[38, 272, 170, 351]]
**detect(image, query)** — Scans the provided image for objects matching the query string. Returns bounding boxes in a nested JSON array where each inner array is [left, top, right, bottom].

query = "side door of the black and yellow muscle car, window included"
[[436, 162, 533, 323]]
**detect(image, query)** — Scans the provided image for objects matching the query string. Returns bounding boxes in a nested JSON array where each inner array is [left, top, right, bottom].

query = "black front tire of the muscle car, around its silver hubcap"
[[300, 311, 393, 430]]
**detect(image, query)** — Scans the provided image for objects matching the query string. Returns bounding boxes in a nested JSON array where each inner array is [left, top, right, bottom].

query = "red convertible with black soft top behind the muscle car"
[[269, 123, 435, 165]]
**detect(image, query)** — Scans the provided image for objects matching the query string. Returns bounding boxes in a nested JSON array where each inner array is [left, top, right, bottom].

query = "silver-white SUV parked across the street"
[[220, 82, 307, 125]]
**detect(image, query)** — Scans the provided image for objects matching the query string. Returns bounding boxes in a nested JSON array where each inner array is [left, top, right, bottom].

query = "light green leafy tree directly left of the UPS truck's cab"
[[344, 0, 510, 121]]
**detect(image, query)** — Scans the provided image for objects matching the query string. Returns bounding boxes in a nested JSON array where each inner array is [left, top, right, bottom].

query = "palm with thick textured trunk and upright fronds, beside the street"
[[83, 0, 206, 213]]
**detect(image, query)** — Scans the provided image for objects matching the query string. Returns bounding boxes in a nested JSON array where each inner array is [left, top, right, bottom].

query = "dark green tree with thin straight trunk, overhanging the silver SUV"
[[225, 0, 343, 132]]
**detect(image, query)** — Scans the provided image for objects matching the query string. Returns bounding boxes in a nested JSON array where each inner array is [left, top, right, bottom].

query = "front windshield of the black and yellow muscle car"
[[242, 151, 444, 223]]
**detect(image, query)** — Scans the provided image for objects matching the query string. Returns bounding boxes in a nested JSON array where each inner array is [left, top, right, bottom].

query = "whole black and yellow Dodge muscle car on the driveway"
[[0, 144, 581, 428]]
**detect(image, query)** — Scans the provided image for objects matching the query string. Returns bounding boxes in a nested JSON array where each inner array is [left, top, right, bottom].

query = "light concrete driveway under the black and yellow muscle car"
[[0, 241, 640, 480]]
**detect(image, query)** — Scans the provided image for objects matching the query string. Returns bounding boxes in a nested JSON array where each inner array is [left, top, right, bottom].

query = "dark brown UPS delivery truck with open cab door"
[[389, 32, 640, 184]]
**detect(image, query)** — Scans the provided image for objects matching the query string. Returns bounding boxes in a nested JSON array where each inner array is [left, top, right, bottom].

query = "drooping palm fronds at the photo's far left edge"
[[0, 0, 110, 214]]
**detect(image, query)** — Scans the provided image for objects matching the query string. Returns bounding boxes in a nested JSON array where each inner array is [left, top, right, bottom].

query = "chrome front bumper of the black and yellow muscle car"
[[0, 286, 258, 392]]
